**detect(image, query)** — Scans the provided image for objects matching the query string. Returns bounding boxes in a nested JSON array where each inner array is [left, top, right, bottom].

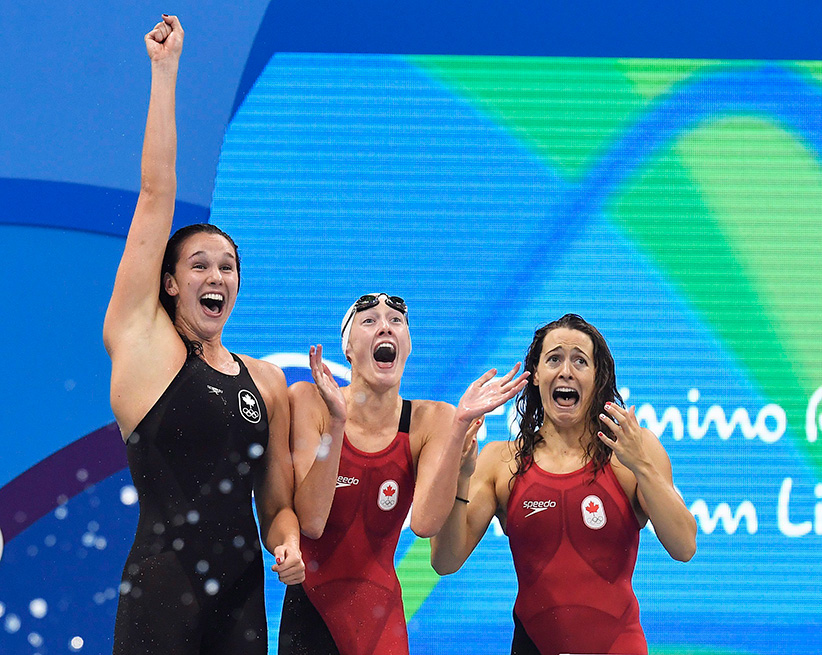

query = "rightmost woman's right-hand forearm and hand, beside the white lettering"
[[599, 403, 696, 562]]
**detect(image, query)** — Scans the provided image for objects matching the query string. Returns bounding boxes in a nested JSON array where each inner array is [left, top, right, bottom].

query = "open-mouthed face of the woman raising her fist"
[[163, 232, 239, 340]]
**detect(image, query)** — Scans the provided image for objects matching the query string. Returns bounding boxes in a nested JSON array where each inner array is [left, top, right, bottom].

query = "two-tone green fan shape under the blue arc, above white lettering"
[[608, 117, 822, 468]]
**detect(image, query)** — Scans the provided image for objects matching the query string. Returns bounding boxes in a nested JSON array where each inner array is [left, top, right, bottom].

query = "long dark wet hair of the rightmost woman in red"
[[512, 314, 624, 480]]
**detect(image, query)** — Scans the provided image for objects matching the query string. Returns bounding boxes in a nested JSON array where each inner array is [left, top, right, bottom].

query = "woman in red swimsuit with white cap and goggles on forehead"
[[280, 293, 527, 655]]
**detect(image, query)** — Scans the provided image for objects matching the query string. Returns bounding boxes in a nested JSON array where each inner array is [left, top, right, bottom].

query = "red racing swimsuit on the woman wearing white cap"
[[292, 400, 414, 655]]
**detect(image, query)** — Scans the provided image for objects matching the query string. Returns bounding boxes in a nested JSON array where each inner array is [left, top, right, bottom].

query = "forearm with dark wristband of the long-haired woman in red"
[[431, 439, 506, 575]]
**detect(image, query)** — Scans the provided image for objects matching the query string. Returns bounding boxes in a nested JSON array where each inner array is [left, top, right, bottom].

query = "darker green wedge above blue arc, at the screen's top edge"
[[409, 56, 647, 179]]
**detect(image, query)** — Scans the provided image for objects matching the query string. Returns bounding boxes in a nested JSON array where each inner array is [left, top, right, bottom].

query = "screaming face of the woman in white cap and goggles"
[[345, 296, 411, 386]]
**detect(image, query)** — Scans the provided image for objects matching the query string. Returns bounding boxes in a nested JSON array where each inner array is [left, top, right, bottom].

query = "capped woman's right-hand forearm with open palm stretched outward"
[[411, 364, 528, 537]]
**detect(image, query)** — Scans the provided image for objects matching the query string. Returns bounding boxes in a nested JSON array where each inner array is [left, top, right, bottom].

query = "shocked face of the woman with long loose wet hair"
[[531, 327, 596, 428]]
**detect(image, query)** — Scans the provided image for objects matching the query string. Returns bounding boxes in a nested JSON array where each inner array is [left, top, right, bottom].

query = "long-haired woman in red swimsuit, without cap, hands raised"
[[431, 314, 696, 655]]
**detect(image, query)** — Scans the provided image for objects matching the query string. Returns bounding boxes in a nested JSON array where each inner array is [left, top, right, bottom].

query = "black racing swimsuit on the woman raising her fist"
[[114, 355, 268, 655]]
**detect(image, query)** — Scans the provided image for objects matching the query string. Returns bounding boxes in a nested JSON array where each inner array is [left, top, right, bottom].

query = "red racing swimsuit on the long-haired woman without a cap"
[[506, 462, 648, 655]]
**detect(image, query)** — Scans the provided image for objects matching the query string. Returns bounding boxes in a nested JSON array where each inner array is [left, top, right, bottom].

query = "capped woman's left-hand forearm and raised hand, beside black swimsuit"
[[288, 346, 346, 539]]
